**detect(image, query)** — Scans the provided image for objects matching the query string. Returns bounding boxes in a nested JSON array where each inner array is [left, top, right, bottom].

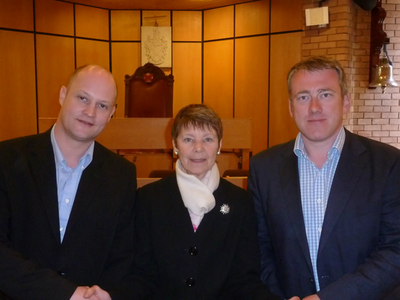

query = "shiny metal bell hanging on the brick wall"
[[369, 44, 398, 93]]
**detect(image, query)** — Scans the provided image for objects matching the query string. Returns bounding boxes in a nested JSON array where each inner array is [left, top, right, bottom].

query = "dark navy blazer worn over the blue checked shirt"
[[248, 130, 400, 300]]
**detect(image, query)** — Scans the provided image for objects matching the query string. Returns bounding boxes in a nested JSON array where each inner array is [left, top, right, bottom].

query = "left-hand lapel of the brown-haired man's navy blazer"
[[279, 143, 312, 270]]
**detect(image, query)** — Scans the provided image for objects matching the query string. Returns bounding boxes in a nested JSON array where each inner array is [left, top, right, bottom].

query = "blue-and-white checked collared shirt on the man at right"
[[293, 127, 346, 291]]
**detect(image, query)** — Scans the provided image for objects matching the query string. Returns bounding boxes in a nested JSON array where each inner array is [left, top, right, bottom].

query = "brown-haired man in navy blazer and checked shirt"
[[248, 57, 400, 300]]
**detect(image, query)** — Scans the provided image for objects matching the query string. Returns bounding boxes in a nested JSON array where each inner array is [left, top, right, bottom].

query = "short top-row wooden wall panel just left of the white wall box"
[[271, 0, 304, 32]]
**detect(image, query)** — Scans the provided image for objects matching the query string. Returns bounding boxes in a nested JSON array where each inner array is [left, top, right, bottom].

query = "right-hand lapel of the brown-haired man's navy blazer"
[[319, 130, 368, 251]]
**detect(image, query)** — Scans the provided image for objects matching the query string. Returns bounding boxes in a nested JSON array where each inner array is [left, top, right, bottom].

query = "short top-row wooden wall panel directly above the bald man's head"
[[75, 5, 109, 40]]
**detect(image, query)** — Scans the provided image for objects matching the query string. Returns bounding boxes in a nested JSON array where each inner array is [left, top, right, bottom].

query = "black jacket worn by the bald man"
[[0, 131, 136, 300]]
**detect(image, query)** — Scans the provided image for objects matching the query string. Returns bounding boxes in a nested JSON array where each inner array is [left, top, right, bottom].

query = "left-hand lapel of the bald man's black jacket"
[[28, 130, 60, 242]]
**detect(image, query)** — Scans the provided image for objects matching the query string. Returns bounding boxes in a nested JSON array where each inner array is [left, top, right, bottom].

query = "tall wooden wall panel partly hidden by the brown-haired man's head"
[[269, 32, 302, 147]]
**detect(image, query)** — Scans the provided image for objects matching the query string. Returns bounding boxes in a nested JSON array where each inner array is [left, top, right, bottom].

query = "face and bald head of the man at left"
[[57, 68, 116, 142]]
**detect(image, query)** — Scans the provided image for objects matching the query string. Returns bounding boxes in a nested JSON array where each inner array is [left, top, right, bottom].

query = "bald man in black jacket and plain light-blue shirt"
[[0, 65, 136, 300]]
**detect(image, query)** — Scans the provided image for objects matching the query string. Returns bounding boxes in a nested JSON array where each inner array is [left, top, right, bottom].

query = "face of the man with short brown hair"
[[289, 69, 350, 144]]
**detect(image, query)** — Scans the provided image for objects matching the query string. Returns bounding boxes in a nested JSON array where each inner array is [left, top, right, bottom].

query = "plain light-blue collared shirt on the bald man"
[[50, 126, 94, 242]]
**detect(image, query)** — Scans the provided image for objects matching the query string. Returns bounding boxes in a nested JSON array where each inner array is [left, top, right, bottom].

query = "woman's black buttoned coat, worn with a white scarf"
[[132, 173, 279, 300]]
